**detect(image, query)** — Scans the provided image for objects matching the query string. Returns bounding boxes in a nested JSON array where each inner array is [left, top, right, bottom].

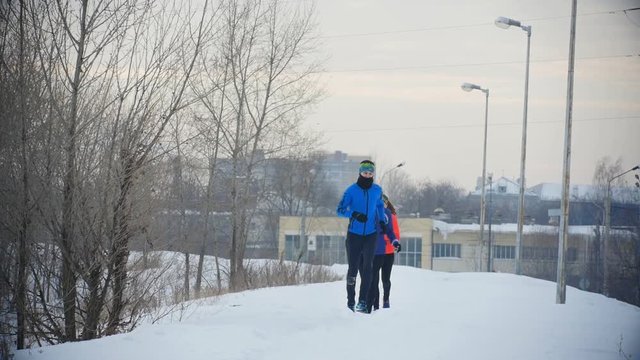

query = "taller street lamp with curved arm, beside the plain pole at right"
[[495, 16, 531, 275]]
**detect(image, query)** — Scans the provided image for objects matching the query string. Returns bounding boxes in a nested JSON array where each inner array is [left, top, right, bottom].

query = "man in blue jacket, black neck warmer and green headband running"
[[336, 160, 388, 313]]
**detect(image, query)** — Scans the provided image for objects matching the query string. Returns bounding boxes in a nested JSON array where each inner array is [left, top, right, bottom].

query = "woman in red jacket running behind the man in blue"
[[367, 195, 402, 310]]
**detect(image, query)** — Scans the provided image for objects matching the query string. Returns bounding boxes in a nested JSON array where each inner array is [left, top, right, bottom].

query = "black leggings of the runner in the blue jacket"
[[345, 232, 378, 306]]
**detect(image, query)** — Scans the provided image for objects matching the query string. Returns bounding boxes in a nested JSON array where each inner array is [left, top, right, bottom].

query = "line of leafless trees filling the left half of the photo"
[[0, 0, 321, 349]]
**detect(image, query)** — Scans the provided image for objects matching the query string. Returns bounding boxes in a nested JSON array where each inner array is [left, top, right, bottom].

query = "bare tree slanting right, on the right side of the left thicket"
[[106, 2, 210, 334]]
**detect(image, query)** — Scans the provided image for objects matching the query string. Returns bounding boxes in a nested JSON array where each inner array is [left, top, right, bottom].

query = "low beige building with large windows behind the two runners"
[[278, 217, 595, 283]]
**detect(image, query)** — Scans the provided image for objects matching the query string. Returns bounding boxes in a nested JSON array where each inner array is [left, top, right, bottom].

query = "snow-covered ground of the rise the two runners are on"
[[11, 265, 640, 360]]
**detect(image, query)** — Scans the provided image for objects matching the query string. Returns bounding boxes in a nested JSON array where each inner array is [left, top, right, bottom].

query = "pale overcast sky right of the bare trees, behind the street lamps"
[[307, 0, 640, 190]]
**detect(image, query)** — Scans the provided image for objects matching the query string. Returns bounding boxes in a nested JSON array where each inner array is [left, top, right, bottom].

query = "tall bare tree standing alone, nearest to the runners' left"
[[190, 0, 319, 290]]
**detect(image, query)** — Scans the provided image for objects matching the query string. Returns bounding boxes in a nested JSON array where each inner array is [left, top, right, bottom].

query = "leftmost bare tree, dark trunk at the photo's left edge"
[[0, 1, 41, 349]]
